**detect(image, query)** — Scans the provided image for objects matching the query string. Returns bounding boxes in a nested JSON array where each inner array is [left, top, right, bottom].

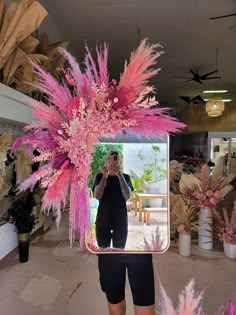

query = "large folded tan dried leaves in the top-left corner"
[[0, 0, 47, 92]]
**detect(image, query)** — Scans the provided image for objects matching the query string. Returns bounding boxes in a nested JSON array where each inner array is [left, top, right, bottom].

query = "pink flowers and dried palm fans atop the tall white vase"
[[179, 164, 235, 209]]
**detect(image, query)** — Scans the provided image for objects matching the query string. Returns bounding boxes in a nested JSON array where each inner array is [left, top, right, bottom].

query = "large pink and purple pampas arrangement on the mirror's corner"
[[10, 39, 185, 247]]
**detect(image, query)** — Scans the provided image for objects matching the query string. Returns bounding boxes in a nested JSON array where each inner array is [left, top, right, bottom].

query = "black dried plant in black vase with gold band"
[[8, 191, 37, 263]]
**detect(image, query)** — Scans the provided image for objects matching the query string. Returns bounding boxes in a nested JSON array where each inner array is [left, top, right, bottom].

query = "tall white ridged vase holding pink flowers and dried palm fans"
[[198, 207, 213, 250]]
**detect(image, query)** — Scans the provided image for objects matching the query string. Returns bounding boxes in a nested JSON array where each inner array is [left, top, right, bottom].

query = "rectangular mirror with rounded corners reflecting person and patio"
[[86, 134, 170, 253]]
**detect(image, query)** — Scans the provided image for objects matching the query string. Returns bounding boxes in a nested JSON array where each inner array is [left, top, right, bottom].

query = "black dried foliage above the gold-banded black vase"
[[8, 191, 37, 233]]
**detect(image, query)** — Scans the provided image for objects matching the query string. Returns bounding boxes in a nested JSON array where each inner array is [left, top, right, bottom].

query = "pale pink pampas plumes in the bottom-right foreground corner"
[[159, 279, 236, 315]]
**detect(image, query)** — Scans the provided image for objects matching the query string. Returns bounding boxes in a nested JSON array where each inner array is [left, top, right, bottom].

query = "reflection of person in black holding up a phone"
[[93, 151, 133, 248]]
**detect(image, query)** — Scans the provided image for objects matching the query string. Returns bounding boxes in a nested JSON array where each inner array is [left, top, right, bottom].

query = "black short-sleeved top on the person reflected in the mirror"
[[92, 173, 133, 229]]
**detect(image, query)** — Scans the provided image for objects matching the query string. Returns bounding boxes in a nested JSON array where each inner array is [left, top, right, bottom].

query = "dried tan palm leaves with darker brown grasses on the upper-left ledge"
[[0, 0, 68, 96]]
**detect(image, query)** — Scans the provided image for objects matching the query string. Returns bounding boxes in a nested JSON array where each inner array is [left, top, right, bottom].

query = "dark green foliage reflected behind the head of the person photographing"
[[88, 143, 123, 188]]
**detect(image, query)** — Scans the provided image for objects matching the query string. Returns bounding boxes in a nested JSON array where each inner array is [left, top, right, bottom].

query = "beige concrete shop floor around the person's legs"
[[0, 212, 236, 315]]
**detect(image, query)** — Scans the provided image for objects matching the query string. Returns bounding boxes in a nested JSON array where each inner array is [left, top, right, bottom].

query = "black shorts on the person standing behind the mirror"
[[98, 254, 155, 306]]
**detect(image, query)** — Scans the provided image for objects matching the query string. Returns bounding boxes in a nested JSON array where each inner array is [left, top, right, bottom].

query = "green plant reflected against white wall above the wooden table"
[[138, 144, 167, 181]]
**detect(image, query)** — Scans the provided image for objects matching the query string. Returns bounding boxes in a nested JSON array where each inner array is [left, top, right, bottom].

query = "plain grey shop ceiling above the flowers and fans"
[[40, 0, 236, 112]]
